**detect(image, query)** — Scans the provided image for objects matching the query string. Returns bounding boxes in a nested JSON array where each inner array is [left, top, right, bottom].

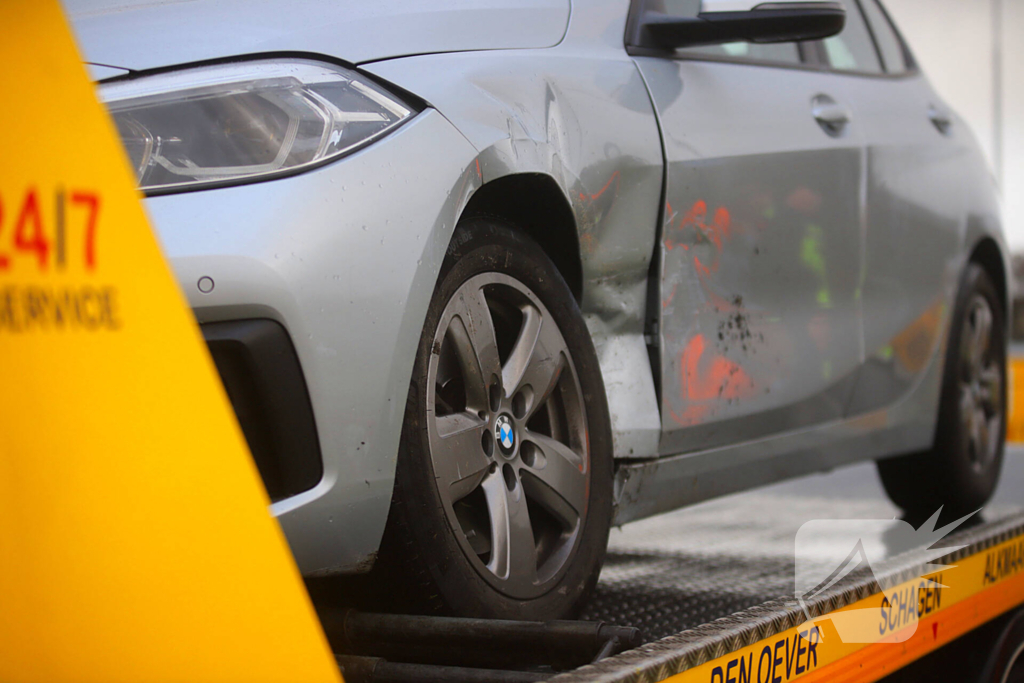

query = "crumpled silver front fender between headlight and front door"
[[365, 1, 663, 464]]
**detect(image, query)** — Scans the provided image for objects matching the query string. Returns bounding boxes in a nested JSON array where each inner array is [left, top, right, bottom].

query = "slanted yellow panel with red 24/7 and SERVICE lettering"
[[0, 0, 340, 683]]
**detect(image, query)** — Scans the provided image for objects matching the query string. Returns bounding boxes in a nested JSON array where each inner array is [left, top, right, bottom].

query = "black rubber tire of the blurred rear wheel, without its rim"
[[878, 263, 1007, 522]]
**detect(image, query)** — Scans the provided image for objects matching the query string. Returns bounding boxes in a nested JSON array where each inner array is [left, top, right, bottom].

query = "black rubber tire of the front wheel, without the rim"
[[373, 217, 612, 621]]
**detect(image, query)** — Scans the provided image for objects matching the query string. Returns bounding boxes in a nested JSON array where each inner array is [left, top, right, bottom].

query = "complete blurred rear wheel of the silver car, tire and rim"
[[878, 263, 1007, 519]]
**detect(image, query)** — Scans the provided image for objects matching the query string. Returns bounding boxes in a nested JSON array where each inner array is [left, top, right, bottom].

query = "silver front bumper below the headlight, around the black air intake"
[[146, 109, 480, 574]]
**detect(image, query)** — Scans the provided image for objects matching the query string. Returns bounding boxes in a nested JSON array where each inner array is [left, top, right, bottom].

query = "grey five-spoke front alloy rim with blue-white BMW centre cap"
[[426, 272, 591, 599]]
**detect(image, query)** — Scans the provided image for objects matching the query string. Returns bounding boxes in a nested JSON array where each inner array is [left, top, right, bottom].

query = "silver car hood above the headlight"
[[63, 0, 570, 71]]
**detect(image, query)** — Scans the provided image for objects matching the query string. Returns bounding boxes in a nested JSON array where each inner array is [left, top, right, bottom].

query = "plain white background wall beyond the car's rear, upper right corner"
[[883, 0, 1024, 253]]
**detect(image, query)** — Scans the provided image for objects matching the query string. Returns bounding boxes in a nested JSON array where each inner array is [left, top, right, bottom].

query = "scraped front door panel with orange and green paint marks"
[[638, 57, 863, 455]]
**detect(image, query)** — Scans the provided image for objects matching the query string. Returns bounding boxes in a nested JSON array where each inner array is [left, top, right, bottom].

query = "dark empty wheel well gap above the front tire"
[[462, 173, 583, 303]]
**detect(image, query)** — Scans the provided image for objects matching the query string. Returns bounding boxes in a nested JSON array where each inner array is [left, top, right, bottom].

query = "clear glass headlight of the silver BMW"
[[100, 60, 414, 194]]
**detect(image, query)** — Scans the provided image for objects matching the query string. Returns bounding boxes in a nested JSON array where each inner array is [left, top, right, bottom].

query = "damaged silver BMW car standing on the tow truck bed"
[[66, 0, 1010, 620]]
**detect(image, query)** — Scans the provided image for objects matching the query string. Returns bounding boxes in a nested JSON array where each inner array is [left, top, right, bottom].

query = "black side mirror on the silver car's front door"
[[629, 0, 846, 51]]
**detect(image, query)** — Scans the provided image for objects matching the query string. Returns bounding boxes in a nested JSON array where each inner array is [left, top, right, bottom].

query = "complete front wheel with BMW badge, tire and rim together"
[[375, 219, 612, 621]]
